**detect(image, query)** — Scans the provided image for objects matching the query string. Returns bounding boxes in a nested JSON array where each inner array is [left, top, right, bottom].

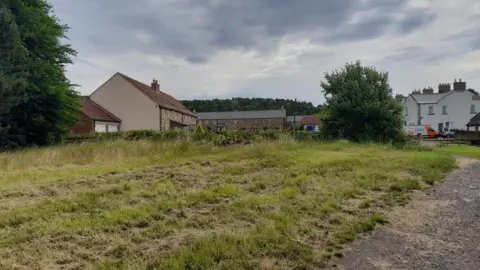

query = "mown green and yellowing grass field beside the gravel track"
[[0, 141, 455, 269]]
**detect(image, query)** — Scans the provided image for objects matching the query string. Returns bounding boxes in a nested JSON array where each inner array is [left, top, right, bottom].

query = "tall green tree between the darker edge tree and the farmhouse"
[[4, 0, 80, 145]]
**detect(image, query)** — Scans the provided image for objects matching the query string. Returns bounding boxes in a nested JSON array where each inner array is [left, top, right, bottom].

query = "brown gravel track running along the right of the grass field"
[[337, 158, 480, 270]]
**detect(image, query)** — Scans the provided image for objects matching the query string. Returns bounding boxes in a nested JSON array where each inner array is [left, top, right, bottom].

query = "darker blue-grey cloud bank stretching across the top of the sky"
[[53, 0, 436, 63]]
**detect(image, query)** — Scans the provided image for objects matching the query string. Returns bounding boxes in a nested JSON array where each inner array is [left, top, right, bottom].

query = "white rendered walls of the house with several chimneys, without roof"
[[404, 91, 480, 130]]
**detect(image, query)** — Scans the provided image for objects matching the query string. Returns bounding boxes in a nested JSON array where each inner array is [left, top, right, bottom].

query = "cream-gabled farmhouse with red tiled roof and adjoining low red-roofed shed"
[[71, 72, 197, 133]]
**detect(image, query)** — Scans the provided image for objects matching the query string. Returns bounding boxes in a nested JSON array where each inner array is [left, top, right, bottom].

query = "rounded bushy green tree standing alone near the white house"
[[321, 61, 402, 142]]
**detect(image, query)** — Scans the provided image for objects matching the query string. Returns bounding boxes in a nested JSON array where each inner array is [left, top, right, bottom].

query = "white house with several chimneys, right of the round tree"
[[403, 80, 480, 131]]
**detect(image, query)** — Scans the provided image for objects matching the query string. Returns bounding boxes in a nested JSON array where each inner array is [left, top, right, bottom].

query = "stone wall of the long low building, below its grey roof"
[[198, 118, 285, 131]]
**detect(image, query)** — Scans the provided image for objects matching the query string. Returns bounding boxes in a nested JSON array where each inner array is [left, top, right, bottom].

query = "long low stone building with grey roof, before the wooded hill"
[[196, 108, 287, 131]]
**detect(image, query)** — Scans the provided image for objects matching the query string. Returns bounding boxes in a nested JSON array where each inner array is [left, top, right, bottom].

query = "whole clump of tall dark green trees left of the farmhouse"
[[0, 0, 80, 148]]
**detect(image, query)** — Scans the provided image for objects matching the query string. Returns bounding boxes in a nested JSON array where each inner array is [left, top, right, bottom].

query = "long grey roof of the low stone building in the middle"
[[195, 110, 287, 120]]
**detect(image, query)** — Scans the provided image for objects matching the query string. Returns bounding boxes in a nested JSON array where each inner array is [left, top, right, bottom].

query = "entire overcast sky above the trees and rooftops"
[[51, 0, 480, 104]]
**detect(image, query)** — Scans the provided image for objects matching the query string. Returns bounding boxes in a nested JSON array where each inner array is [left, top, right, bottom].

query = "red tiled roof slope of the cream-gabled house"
[[118, 73, 195, 116]]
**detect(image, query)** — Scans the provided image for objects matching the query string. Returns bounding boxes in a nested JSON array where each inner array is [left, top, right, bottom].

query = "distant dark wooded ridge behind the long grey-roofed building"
[[181, 97, 321, 115]]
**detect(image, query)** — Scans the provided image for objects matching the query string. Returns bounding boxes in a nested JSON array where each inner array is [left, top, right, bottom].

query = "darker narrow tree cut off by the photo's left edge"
[[0, 3, 28, 149]]
